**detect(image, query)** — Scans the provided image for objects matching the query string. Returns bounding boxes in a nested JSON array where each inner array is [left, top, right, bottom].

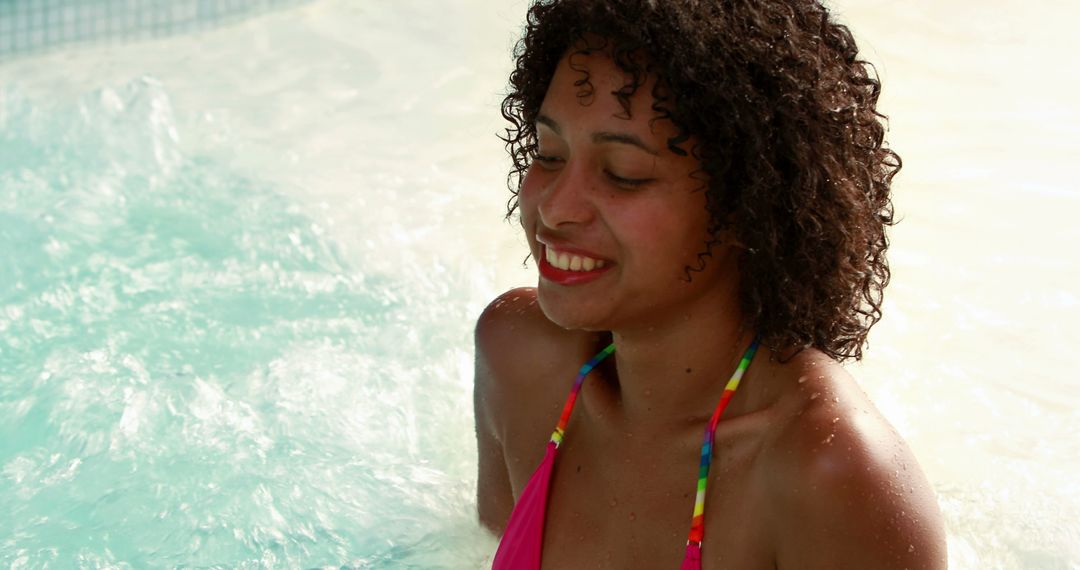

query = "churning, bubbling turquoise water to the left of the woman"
[[0, 79, 494, 568]]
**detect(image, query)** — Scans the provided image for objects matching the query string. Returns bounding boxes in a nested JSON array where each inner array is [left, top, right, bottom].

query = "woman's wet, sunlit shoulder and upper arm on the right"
[[768, 351, 946, 569]]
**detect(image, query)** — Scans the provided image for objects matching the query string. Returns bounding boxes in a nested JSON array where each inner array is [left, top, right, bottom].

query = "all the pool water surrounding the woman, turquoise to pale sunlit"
[[0, 0, 1080, 570]]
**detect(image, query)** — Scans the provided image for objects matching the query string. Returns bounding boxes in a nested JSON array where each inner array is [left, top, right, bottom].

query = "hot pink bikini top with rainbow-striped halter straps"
[[491, 339, 758, 570]]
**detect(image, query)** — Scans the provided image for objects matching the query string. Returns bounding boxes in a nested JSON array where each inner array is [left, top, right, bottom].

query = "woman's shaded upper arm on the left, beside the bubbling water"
[[473, 291, 529, 534]]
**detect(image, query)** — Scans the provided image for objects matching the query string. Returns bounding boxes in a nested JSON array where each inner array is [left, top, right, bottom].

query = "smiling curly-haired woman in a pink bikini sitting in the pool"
[[475, 0, 945, 569]]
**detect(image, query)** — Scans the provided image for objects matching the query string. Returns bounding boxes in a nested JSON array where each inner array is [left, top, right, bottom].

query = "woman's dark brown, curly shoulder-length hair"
[[502, 0, 901, 361]]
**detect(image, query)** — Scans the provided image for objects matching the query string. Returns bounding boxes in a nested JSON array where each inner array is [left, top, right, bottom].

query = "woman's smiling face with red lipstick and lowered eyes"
[[518, 50, 717, 330]]
